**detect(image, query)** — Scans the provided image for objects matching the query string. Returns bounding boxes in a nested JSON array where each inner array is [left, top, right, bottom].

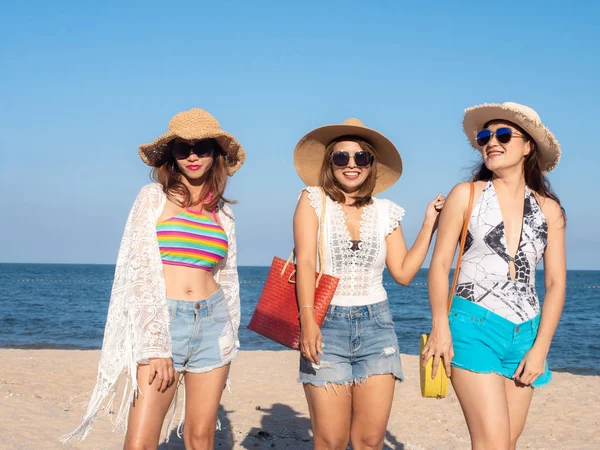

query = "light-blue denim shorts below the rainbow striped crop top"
[[167, 288, 237, 373]]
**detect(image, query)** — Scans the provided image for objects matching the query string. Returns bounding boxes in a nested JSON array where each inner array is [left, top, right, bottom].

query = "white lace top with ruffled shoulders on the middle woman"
[[306, 187, 404, 306]]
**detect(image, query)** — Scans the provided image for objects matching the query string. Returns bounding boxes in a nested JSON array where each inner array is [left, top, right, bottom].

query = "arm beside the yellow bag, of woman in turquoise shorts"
[[421, 183, 470, 378]]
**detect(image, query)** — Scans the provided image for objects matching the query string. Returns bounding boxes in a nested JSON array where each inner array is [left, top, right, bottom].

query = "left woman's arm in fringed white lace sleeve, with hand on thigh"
[[62, 184, 174, 442]]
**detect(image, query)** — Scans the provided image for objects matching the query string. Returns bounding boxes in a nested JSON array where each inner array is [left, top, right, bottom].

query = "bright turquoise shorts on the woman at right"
[[449, 296, 552, 387]]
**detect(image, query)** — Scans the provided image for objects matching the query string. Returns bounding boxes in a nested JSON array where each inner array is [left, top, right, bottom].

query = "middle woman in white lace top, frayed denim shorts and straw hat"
[[294, 119, 444, 449]]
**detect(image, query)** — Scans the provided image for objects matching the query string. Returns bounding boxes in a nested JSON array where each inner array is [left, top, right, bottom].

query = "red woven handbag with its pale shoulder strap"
[[248, 188, 339, 350]]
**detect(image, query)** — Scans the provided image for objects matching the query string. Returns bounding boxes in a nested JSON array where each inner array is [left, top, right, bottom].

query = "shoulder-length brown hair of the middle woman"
[[319, 136, 377, 208]]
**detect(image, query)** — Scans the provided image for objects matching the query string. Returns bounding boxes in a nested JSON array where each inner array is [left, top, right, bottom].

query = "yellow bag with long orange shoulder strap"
[[419, 183, 475, 398]]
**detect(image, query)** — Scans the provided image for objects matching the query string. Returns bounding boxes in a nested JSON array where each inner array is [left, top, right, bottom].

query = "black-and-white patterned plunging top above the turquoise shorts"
[[455, 181, 548, 323]]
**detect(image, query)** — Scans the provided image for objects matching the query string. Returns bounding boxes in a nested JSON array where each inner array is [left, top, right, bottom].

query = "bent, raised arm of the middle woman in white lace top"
[[385, 194, 445, 286]]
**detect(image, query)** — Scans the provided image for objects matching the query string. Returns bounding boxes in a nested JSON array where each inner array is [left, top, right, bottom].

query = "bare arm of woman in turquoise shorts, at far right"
[[513, 199, 567, 385]]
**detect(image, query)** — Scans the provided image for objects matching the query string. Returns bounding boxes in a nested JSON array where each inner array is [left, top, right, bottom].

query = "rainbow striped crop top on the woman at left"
[[156, 208, 228, 270]]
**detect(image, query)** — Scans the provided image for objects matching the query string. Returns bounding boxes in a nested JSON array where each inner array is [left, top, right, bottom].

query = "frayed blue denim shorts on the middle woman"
[[298, 300, 403, 386]]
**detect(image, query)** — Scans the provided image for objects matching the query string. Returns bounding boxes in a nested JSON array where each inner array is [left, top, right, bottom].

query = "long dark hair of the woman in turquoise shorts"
[[471, 120, 567, 224]]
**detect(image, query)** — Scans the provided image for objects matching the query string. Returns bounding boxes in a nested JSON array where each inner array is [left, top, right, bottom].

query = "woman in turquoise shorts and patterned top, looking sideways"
[[422, 103, 566, 449]]
